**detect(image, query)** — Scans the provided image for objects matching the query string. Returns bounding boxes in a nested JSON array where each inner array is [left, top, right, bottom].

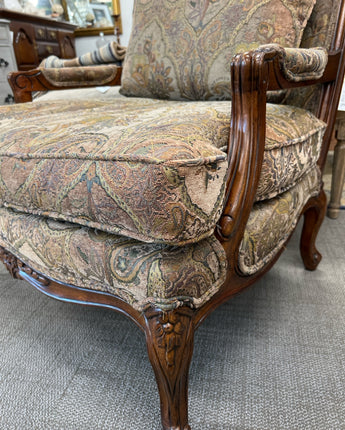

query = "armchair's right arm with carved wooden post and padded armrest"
[[216, 45, 340, 269]]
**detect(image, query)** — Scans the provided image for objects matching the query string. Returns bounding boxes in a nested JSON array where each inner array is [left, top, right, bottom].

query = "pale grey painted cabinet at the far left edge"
[[0, 19, 17, 105]]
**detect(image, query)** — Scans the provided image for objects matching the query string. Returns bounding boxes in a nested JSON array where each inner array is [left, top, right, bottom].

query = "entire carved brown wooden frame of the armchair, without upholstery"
[[0, 2, 345, 430]]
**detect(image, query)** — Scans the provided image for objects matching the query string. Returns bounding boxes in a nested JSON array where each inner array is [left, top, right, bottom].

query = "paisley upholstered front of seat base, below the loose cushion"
[[0, 208, 227, 310]]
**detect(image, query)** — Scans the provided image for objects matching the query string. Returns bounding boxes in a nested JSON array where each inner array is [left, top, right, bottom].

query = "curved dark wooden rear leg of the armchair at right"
[[300, 190, 327, 270]]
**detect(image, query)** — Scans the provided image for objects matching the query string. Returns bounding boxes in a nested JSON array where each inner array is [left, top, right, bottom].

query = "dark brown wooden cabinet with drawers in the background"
[[0, 9, 76, 70]]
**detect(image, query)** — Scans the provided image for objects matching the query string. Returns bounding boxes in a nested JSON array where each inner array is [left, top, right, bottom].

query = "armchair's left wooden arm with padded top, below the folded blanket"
[[8, 64, 122, 103]]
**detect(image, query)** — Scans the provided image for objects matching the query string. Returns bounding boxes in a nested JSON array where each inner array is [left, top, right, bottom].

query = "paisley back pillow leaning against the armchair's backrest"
[[121, 0, 316, 100]]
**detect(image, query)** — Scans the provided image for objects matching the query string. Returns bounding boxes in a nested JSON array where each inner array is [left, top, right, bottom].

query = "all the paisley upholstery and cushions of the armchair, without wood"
[[0, 0, 334, 311]]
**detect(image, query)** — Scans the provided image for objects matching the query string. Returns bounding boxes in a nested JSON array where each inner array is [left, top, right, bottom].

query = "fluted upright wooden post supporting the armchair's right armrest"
[[217, 51, 268, 260]]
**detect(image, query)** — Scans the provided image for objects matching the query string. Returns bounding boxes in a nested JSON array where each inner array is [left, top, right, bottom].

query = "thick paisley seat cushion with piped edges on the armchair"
[[0, 97, 325, 245]]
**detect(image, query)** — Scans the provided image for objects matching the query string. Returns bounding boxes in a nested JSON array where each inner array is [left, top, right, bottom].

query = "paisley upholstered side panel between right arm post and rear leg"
[[239, 166, 321, 275]]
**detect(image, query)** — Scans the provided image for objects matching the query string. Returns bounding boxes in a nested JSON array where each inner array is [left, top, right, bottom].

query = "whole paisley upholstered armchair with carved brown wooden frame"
[[0, 0, 345, 430]]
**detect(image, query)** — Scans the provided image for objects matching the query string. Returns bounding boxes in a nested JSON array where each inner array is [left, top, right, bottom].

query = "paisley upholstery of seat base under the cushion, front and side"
[[0, 168, 320, 311]]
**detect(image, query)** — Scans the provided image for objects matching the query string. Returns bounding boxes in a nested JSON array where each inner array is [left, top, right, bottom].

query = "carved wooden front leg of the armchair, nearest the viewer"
[[145, 307, 194, 430]]
